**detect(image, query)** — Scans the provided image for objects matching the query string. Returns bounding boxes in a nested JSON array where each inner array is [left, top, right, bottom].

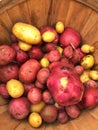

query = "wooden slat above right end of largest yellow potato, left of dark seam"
[[27, 0, 51, 27]]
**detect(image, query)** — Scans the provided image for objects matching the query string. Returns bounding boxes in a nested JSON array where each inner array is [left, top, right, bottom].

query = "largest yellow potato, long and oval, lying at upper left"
[[12, 22, 41, 44]]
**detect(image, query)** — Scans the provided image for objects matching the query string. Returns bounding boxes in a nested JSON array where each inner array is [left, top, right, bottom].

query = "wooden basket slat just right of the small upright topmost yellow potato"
[[66, 1, 92, 31]]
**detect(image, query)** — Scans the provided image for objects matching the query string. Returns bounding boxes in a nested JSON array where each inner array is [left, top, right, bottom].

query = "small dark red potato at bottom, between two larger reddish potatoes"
[[57, 110, 69, 124]]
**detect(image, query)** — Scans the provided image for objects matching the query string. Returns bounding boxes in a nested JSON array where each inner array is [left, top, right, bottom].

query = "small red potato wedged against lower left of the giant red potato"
[[42, 90, 54, 104]]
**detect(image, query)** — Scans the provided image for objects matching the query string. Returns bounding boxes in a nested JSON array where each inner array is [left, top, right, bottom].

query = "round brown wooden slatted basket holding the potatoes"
[[0, 0, 98, 130]]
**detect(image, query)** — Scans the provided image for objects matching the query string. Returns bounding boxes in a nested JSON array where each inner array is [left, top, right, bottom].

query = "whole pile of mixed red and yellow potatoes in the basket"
[[0, 21, 98, 128]]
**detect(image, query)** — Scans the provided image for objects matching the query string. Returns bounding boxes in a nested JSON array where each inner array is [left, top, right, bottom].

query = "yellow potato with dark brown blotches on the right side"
[[81, 55, 94, 69]]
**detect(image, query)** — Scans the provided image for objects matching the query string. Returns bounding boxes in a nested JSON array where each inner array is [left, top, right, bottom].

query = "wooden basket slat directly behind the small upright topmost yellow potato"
[[48, 0, 70, 25]]
